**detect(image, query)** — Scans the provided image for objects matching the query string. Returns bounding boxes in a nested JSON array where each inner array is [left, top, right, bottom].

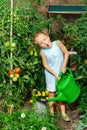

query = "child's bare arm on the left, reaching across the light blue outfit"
[[40, 51, 60, 80]]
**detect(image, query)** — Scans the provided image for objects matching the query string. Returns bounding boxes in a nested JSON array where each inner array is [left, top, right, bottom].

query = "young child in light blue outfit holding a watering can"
[[34, 32, 70, 121]]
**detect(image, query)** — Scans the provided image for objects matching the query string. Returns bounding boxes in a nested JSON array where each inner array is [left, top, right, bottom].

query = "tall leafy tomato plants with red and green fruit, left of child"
[[0, 0, 50, 109]]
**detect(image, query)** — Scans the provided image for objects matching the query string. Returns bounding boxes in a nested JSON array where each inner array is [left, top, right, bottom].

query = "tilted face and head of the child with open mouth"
[[36, 34, 51, 48]]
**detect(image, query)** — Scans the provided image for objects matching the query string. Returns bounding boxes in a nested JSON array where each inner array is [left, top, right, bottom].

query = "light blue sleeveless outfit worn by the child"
[[42, 41, 64, 92]]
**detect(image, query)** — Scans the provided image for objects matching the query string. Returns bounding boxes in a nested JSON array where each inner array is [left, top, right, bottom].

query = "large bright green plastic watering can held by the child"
[[48, 68, 80, 104]]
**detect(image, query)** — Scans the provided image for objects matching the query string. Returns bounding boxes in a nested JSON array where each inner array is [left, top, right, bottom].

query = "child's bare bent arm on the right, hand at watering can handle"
[[57, 40, 69, 73]]
